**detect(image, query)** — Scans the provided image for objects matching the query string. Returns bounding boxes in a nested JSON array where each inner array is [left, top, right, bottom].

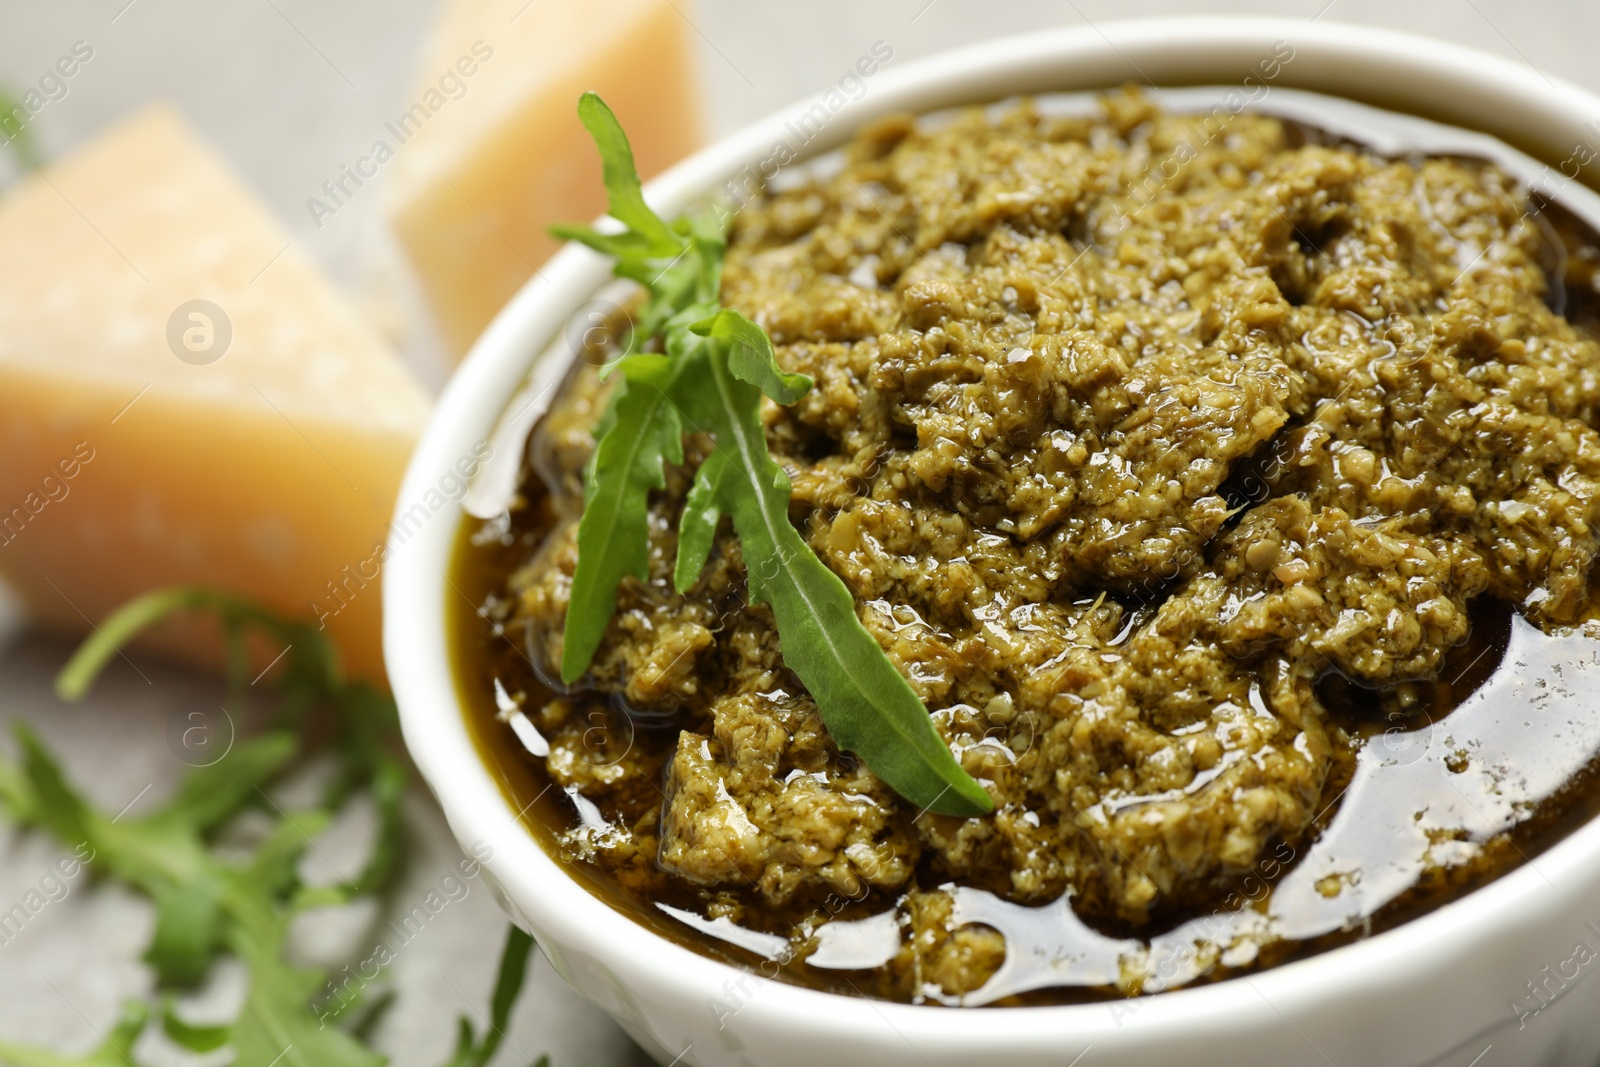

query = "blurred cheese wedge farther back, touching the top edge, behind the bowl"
[[387, 0, 701, 355]]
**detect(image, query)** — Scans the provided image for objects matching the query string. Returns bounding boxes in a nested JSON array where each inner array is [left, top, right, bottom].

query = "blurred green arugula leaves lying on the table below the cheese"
[[0, 587, 544, 1067]]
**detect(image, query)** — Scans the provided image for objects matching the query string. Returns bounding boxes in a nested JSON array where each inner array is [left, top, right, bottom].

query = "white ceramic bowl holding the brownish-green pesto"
[[384, 18, 1600, 1067]]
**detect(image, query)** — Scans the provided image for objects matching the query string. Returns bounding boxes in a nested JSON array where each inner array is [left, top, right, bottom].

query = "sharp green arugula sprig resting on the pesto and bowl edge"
[[552, 93, 994, 816]]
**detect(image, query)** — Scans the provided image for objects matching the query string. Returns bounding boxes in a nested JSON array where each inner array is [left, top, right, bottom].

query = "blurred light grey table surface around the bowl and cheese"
[[0, 0, 1600, 1067]]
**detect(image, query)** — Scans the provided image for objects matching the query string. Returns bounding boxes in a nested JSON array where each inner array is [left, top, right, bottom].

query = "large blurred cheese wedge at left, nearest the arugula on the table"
[[0, 107, 429, 678]]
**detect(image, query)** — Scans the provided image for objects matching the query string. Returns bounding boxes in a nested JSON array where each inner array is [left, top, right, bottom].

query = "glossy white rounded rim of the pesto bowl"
[[382, 16, 1600, 1051]]
